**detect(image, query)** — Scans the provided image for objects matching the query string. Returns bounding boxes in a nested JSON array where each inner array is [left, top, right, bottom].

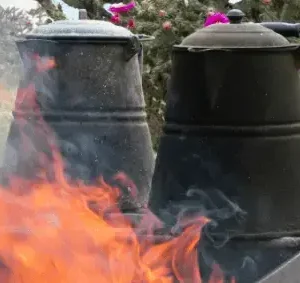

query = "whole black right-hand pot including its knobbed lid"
[[149, 10, 300, 282]]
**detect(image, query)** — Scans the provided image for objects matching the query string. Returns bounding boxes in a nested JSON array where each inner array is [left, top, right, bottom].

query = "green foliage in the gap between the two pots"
[[134, 0, 209, 147]]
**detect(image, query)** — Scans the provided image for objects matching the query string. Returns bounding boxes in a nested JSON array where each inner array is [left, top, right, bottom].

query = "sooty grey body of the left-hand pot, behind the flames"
[[5, 37, 154, 209]]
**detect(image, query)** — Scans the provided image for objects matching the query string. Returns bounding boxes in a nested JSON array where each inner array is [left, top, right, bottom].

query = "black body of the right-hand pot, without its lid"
[[150, 49, 300, 236]]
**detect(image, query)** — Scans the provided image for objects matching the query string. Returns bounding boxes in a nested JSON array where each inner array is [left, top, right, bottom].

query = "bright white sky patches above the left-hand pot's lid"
[[0, 0, 78, 20]]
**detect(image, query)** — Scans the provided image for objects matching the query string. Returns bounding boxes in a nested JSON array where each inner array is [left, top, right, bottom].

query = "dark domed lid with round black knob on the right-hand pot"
[[177, 9, 292, 49]]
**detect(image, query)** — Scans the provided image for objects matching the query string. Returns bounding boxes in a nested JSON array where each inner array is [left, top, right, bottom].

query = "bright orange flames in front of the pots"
[[0, 52, 234, 283]]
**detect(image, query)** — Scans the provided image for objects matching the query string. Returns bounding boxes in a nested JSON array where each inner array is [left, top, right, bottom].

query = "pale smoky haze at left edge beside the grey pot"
[[0, 5, 46, 169]]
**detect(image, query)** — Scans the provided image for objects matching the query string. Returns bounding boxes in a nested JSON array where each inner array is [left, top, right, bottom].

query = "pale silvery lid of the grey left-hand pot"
[[26, 20, 134, 40]]
